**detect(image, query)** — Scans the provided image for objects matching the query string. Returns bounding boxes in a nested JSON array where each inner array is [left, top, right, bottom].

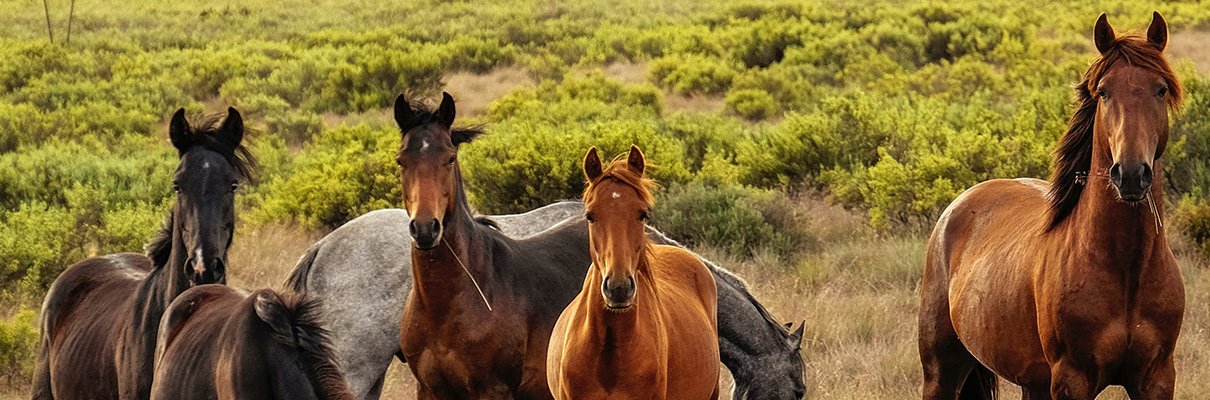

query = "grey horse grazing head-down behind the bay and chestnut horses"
[[286, 201, 806, 400]]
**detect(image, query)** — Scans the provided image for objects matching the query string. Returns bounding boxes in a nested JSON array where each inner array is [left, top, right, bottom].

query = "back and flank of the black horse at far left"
[[34, 253, 151, 399]]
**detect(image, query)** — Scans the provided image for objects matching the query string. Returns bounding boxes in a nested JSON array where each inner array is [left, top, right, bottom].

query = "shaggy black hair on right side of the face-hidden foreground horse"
[[254, 290, 353, 400]]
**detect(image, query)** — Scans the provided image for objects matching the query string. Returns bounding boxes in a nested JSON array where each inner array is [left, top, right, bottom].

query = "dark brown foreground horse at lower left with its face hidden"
[[151, 284, 353, 400]]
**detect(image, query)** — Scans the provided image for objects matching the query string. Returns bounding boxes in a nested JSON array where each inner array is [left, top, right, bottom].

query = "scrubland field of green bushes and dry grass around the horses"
[[0, 0, 1210, 399]]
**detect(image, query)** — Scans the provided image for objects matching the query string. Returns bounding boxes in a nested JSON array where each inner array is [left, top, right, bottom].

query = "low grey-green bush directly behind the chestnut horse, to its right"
[[651, 181, 817, 256]]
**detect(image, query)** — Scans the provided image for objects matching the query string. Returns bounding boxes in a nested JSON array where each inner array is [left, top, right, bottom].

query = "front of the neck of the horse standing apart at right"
[[1068, 129, 1168, 263]]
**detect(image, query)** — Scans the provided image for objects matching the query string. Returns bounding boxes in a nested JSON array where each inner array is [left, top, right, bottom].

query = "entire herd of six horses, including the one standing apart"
[[33, 12, 1185, 399]]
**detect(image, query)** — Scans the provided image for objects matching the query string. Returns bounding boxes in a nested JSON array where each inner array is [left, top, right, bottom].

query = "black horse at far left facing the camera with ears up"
[[33, 109, 255, 399]]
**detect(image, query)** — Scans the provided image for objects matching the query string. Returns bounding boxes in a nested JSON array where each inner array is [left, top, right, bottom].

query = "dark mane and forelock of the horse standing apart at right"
[[1047, 35, 1183, 231]]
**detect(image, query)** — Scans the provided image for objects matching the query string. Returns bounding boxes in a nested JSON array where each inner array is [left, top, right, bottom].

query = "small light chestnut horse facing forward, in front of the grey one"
[[547, 146, 719, 399]]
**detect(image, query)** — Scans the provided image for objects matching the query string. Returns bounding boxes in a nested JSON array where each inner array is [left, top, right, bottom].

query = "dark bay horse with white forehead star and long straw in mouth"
[[394, 94, 589, 399]]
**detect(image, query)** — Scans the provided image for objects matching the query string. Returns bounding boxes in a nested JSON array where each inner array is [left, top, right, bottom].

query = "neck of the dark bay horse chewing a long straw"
[[409, 169, 496, 312]]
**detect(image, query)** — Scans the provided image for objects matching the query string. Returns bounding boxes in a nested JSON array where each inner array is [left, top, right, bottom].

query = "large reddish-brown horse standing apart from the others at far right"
[[920, 12, 1185, 399]]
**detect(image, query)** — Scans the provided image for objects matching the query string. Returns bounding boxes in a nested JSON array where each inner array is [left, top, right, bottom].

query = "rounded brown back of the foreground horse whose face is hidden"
[[151, 284, 244, 399]]
